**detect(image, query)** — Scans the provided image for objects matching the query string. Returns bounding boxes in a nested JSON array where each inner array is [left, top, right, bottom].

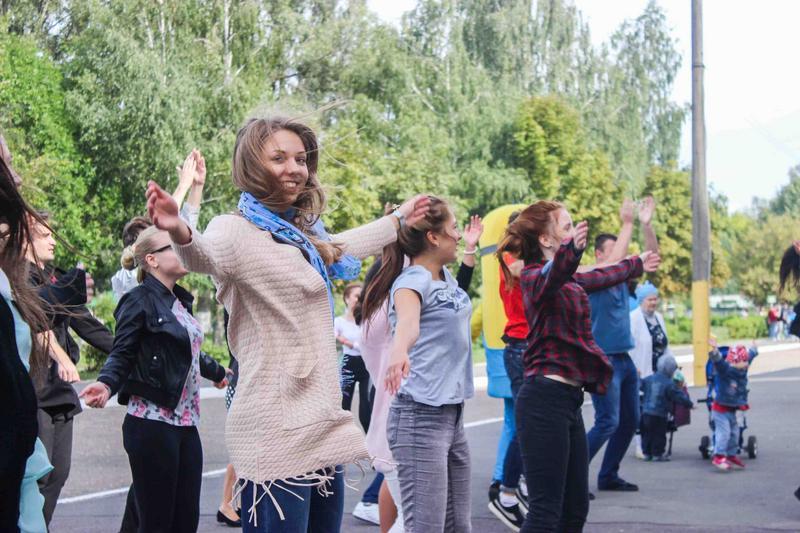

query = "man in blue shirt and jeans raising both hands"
[[586, 197, 658, 491]]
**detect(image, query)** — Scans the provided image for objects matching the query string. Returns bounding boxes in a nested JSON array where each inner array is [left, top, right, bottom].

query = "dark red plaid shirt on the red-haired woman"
[[520, 239, 643, 394]]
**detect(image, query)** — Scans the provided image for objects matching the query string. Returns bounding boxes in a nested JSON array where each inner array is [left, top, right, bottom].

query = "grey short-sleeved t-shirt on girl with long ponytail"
[[389, 266, 475, 406]]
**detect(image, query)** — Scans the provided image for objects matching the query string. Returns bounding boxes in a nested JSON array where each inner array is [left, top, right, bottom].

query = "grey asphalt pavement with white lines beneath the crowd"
[[51, 360, 800, 533]]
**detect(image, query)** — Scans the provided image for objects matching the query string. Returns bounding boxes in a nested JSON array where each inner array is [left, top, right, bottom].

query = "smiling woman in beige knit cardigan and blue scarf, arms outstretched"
[[147, 117, 429, 533]]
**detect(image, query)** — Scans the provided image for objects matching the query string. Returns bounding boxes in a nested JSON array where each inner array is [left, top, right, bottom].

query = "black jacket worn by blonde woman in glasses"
[[97, 276, 225, 409]]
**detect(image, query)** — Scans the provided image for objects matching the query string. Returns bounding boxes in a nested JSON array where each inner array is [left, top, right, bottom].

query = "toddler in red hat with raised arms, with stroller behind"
[[700, 339, 758, 471]]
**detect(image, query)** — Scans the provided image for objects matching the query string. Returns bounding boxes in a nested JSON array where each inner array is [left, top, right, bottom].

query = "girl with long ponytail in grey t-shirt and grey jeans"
[[363, 198, 482, 532]]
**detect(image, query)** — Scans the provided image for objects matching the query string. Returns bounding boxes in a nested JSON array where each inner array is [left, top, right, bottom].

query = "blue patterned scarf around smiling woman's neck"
[[239, 192, 361, 313]]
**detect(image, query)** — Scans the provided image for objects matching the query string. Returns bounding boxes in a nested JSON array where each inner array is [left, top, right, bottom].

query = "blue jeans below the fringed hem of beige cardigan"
[[242, 467, 344, 533]]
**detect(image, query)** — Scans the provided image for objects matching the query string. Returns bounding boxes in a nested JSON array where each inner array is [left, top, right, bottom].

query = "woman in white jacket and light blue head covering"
[[630, 281, 672, 458]]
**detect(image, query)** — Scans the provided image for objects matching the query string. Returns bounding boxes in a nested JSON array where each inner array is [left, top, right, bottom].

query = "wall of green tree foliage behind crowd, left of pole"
[[0, 0, 689, 296]]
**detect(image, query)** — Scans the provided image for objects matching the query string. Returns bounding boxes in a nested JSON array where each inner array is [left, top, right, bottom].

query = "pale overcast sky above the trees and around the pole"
[[367, 0, 800, 209]]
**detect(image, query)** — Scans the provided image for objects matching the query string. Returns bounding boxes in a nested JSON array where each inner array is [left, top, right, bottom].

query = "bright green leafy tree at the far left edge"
[[0, 29, 109, 268]]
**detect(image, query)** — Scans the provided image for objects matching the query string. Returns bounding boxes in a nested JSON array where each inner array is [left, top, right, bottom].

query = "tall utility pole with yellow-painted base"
[[692, 0, 711, 385]]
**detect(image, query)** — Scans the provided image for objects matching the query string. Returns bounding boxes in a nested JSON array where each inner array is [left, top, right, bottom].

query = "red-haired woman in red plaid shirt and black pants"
[[497, 201, 660, 532]]
